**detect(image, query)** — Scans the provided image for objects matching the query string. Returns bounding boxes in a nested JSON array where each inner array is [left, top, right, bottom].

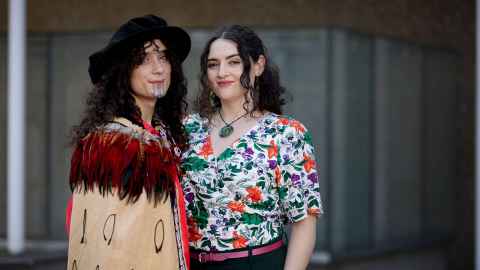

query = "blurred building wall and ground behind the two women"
[[0, 0, 475, 270]]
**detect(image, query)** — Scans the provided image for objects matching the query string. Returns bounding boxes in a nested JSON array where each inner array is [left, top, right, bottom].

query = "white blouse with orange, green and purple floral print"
[[182, 113, 322, 251]]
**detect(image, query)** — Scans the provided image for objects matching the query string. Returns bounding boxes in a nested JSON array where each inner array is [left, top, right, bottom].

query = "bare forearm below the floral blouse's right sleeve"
[[284, 216, 317, 270]]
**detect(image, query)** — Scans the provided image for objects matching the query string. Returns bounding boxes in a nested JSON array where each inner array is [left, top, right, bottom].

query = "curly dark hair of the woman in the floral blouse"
[[195, 25, 286, 118]]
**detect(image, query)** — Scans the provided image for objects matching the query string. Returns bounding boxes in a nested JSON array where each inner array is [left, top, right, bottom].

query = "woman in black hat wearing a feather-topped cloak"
[[67, 15, 190, 269]]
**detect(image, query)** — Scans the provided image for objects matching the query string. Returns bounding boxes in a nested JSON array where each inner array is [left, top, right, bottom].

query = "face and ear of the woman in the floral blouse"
[[207, 38, 264, 104]]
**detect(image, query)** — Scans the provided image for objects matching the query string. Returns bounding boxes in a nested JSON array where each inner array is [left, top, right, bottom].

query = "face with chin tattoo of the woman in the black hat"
[[130, 39, 172, 100]]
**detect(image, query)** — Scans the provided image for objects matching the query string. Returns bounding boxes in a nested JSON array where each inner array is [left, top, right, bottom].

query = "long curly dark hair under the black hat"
[[70, 37, 188, 150]]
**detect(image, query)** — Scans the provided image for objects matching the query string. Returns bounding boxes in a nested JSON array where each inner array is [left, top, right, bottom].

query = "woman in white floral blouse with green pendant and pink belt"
[[183, 25, 322, 269]]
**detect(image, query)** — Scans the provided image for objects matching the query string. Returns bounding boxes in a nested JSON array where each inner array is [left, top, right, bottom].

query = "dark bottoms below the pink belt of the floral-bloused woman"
[[190, 245, 287, 270]]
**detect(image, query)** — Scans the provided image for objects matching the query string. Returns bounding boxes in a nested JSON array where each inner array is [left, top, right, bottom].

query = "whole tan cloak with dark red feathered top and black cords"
[[67, 122, 189, 270]]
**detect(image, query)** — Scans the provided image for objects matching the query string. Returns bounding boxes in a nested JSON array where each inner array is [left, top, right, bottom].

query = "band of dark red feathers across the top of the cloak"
[[70, 130, 179, 202]]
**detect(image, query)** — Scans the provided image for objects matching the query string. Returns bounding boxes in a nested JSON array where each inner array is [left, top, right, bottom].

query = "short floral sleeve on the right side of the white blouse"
[[277, 118, 323, 223]]
